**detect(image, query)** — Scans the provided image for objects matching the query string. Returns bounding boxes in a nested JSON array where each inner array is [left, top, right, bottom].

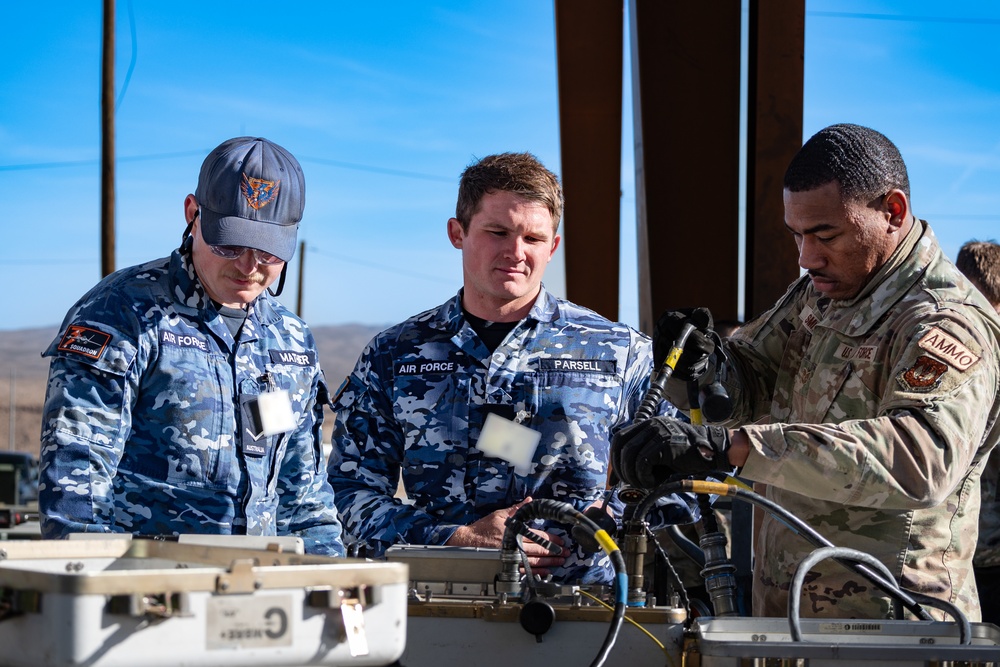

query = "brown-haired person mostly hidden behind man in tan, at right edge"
[[955, 241, 1000, 625]]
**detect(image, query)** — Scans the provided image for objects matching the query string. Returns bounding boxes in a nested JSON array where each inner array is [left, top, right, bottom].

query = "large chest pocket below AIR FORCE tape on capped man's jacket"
[[121, 345, 235, 488]]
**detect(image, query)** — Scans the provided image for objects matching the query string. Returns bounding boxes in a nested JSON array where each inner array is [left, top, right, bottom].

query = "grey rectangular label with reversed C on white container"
[[205, 595, 292, 649]]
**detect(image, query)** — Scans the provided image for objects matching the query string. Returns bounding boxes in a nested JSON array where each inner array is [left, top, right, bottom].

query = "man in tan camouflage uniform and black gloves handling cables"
[[614, 125, 1000, 621]]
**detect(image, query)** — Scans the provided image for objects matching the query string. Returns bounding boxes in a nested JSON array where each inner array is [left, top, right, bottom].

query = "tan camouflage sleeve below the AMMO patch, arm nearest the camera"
[[743, 310, 997, 509]]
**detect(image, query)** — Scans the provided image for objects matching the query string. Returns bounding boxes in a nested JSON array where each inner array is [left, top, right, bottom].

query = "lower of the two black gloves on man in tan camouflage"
[[611, 417, 733, 489]]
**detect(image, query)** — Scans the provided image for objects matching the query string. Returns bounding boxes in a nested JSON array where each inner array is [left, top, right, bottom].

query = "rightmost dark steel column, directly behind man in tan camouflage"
[[744, 0, 805, 319]]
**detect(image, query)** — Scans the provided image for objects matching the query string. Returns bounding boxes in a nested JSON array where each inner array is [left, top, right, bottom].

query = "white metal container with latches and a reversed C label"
[[0, 539, 408, 667]]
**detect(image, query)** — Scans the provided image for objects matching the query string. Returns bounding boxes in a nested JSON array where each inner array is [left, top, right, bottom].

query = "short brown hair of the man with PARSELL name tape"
[[455, 153, 563, 231]]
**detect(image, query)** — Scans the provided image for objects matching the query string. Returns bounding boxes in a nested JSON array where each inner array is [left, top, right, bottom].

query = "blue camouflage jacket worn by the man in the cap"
[[38, 251, 344, 555]]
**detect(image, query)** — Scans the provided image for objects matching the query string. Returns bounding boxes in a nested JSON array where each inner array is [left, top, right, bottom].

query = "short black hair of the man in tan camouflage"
[[784, 123, 910, 203]]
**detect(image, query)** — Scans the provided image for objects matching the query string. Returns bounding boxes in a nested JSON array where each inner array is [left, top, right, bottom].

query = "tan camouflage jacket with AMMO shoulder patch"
[[726, 221, 1000, 621]]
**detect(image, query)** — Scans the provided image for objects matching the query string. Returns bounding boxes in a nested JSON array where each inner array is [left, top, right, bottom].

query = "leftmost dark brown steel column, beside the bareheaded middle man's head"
[[555, 0, 624, 320]]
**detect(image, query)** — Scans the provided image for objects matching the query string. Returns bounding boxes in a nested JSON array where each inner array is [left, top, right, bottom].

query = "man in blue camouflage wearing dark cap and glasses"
[[38, 137, 344, 555]]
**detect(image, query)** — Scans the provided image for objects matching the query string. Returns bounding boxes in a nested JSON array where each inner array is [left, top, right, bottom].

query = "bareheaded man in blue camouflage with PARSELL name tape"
[[330, 153, 691, 583]]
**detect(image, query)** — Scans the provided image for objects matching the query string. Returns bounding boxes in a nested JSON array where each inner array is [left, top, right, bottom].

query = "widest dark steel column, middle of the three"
[[630, 0, 740, 332]]
